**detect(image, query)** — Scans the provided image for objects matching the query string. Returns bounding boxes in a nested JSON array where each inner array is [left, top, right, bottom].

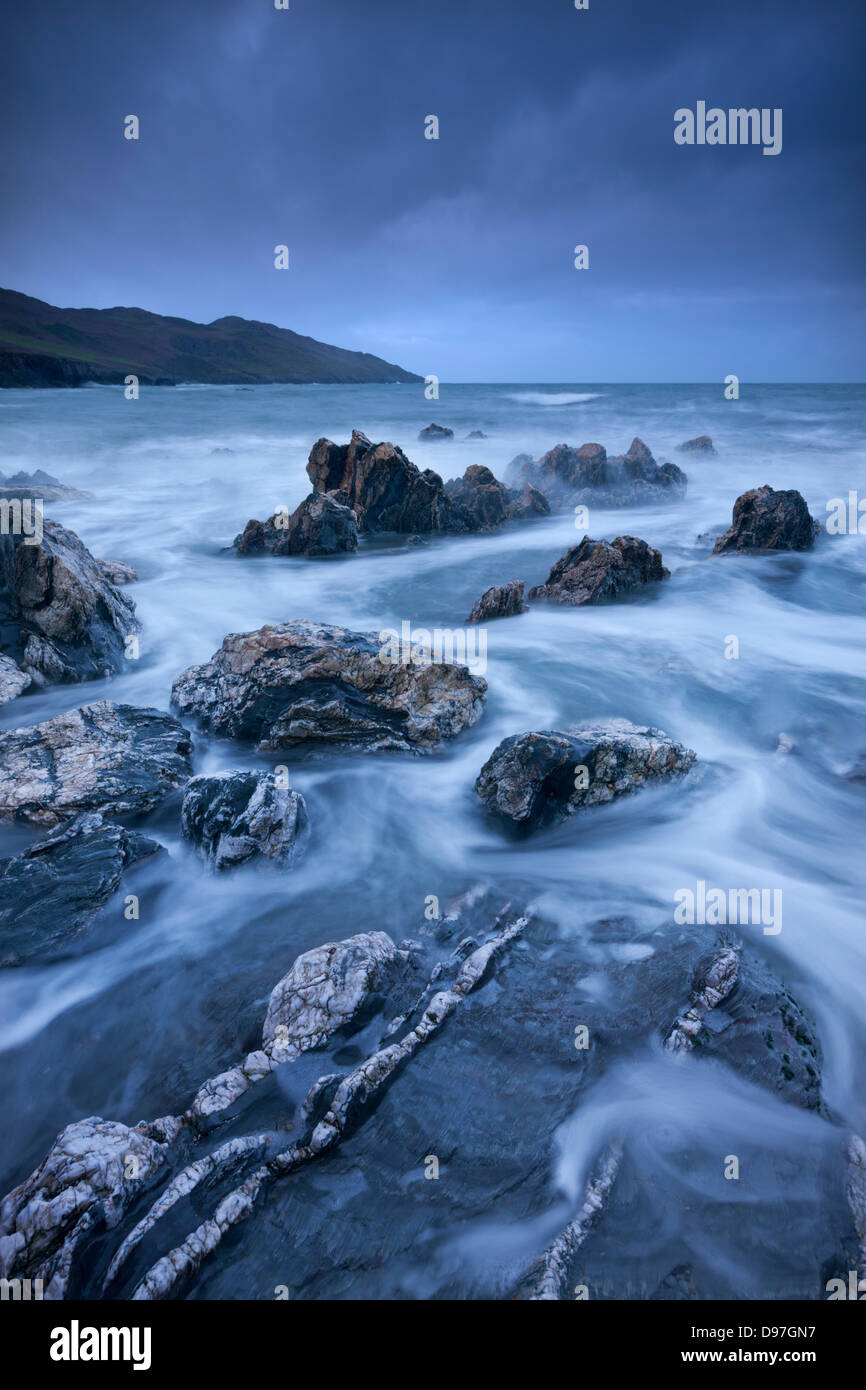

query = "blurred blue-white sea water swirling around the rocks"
[[0, 384, 866, 1298]]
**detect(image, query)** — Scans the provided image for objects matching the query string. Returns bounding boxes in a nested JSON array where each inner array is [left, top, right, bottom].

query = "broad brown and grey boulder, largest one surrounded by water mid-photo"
[[171, 620, 487, 752]]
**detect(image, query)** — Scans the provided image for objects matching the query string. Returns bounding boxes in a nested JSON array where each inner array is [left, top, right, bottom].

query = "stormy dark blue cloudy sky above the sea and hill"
[[0, 0, 866, 382]]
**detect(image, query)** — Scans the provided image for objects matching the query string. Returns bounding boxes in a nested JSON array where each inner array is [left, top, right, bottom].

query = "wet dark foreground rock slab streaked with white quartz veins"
[[0, 891, 851, 1300]]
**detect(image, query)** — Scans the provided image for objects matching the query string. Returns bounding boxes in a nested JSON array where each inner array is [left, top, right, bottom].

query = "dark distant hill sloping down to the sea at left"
[[0, 289, 423, 386]]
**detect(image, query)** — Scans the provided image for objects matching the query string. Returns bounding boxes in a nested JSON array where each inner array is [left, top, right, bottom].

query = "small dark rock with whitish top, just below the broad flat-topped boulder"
[[181, 771, 307, 869]]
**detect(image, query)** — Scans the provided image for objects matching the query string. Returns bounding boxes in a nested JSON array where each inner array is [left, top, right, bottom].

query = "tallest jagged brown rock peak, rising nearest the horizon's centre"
[[307, 430, 461, 534]]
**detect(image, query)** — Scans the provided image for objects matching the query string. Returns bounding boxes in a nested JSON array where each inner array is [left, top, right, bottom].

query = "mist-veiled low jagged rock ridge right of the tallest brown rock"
[[507, 438, 687, 507]]
